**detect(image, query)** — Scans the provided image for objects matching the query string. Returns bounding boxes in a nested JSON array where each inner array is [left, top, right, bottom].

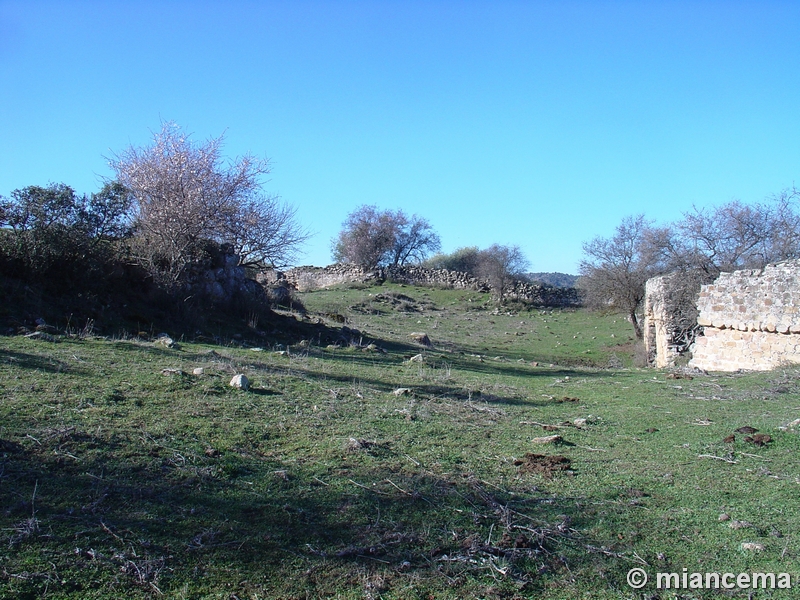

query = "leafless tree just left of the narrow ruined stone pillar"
[[578, 215, 658, 339]]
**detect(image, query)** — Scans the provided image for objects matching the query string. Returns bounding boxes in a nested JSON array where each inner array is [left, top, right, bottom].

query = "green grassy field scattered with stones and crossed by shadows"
[[0, 285, 800, 599]]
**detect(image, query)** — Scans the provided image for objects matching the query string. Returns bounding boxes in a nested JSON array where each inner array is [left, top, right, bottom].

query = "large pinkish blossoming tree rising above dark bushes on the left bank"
[[109, 122, 307, 289]]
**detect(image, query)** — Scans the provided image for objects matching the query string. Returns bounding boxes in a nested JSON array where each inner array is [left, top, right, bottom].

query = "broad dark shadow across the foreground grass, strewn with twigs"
[[0, 431, 624, 598]]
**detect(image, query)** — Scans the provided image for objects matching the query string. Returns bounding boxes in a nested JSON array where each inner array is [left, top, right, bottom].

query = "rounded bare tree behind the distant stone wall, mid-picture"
[[333, 206, 441, 269]]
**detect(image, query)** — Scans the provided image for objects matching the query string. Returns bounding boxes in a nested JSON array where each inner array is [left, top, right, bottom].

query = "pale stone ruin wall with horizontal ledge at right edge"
[[689, 260, 800, 371]]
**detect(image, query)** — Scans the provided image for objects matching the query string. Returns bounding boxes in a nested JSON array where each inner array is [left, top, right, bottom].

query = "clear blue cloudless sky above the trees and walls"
[[0, 0, 800, 273]]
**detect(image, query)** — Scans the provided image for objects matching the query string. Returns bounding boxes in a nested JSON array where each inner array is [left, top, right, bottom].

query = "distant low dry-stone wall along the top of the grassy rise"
[[257, 264, 580, 306]]
